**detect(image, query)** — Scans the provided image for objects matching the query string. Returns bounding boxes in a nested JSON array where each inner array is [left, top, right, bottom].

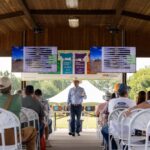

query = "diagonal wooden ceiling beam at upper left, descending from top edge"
[[17, 0, 38, 29]]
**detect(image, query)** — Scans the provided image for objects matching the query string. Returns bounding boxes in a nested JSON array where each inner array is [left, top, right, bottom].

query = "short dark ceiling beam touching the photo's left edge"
[[0, 11, 24, 20]]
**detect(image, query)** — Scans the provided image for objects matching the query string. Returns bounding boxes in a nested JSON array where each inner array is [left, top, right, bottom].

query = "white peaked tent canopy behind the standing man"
[[48, 80, 105, 103]]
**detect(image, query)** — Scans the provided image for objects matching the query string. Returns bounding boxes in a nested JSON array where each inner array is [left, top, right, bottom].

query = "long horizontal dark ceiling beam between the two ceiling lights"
[[30, 9, 116, 15]]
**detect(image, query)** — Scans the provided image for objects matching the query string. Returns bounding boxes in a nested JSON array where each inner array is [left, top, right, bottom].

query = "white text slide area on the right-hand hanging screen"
[[102, 47, 136, 73]]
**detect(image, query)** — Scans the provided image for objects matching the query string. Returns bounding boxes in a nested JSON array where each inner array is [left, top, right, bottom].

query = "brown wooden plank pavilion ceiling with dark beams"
[[0, 0, 150, 33]]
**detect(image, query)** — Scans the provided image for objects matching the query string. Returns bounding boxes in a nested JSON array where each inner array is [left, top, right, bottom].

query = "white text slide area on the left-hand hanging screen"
[[23, 46, 57, 73]]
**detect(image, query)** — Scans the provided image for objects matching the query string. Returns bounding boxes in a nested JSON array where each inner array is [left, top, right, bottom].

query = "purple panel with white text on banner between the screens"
[[75, 53, 87, 74]]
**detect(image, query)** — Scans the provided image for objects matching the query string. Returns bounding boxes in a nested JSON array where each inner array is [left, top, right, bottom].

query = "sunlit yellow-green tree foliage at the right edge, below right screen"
[[128, 67, 150, 100]]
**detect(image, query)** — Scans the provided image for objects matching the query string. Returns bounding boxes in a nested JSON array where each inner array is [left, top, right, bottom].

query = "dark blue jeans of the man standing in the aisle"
[[70, 105, 82, 133]]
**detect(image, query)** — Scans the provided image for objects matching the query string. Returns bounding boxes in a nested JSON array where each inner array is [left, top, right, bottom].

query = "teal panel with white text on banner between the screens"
[[60, 53, 73, 74]]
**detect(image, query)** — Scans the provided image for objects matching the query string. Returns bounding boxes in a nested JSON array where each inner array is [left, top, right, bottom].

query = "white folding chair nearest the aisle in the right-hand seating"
[[108, 108, 125, 150]]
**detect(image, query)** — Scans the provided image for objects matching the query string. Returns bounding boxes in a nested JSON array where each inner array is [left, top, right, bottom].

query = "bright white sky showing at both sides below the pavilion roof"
[[0, 57, 150, 77]]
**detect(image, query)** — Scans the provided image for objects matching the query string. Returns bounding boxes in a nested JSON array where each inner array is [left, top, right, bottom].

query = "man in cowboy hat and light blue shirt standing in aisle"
[[67, 78, 87, 136]]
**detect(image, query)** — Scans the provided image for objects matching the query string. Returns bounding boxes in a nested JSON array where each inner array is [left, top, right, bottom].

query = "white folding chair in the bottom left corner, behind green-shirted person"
[[0, 108, 22, 150]]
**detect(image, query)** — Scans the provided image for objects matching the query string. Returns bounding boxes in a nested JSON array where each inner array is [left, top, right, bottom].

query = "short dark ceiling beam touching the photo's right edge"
[[122, 11, 150, 21]]
